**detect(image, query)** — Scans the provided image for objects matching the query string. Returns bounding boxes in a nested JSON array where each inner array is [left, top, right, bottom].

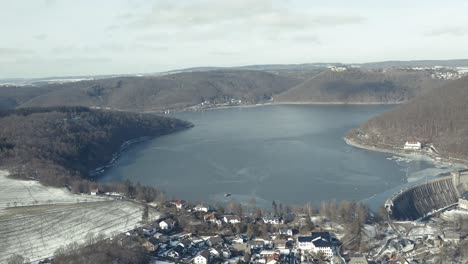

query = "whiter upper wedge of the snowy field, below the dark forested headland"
[[0, 170, 107, 211]]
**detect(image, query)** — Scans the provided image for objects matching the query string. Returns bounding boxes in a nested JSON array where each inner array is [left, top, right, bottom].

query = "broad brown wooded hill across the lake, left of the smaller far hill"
[[18, 70, 300, 111]]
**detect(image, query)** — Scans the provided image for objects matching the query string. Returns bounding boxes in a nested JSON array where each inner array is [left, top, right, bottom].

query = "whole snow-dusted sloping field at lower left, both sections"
[[0, 173, 160, 263]]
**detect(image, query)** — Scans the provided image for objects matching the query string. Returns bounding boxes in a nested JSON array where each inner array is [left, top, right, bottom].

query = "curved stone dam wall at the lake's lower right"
[[385, 171, 468, 220]]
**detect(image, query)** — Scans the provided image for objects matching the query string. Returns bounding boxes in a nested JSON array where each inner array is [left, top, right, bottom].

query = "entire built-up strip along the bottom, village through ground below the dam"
[[79, 174, 468, 264]]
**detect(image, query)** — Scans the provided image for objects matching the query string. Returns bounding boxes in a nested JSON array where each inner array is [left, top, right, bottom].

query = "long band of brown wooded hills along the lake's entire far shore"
[[0, 64, 454, 112]]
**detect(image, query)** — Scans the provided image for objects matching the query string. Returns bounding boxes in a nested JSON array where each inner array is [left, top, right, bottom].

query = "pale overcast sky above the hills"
[[0, 0, 468, 78]]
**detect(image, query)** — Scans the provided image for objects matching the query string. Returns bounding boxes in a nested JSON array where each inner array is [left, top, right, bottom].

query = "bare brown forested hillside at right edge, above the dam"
[[348, 77, 468, 160]]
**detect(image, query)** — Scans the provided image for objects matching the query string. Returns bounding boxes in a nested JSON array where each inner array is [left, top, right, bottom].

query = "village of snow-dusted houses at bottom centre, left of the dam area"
[[116, 200, 354, 264]]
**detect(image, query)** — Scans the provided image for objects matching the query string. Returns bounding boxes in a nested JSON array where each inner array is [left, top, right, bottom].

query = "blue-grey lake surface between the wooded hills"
[[101, 105, 450, 207]]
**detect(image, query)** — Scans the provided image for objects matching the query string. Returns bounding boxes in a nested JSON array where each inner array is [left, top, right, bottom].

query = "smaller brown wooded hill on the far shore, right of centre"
[[275, 69, 443, 103]]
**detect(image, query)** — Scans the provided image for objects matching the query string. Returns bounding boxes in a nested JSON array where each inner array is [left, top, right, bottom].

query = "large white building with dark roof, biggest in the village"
[[297, 232, 335, 258]]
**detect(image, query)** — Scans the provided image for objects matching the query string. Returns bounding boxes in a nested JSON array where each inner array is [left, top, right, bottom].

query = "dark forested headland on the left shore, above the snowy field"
[[0, 107, 192, 186]]
